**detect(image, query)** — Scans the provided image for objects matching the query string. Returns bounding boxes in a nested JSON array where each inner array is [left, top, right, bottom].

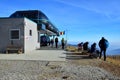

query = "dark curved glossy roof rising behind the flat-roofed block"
[[9, 10, 59, 35]]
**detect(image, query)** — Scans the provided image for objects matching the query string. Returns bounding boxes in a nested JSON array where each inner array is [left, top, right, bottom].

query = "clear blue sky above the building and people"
[[0, 0, 120, 47]]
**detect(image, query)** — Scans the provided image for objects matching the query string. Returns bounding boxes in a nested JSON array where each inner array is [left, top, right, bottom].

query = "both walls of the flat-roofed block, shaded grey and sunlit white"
[[0, 18, 40, 53]]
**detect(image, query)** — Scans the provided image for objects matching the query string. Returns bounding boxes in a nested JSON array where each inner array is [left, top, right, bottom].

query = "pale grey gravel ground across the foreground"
[[0, 60, 120, 80]]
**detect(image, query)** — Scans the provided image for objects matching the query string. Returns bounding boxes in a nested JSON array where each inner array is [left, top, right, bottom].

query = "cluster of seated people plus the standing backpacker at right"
[[78, 37, 109, 61]]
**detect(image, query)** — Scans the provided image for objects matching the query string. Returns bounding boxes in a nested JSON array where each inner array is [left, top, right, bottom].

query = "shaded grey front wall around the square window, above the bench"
[[0, 18, 24, 52]]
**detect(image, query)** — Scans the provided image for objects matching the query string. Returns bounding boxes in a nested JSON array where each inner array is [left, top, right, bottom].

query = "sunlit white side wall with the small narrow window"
[[24, 18, 40, 53]]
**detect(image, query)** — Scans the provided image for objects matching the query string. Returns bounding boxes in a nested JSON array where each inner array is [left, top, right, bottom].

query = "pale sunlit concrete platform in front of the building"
[[0, 50, 66, 61]]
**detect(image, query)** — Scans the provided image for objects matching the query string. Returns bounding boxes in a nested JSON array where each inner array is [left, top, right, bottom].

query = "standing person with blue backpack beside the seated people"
[[99, 37, 109, 61]]
